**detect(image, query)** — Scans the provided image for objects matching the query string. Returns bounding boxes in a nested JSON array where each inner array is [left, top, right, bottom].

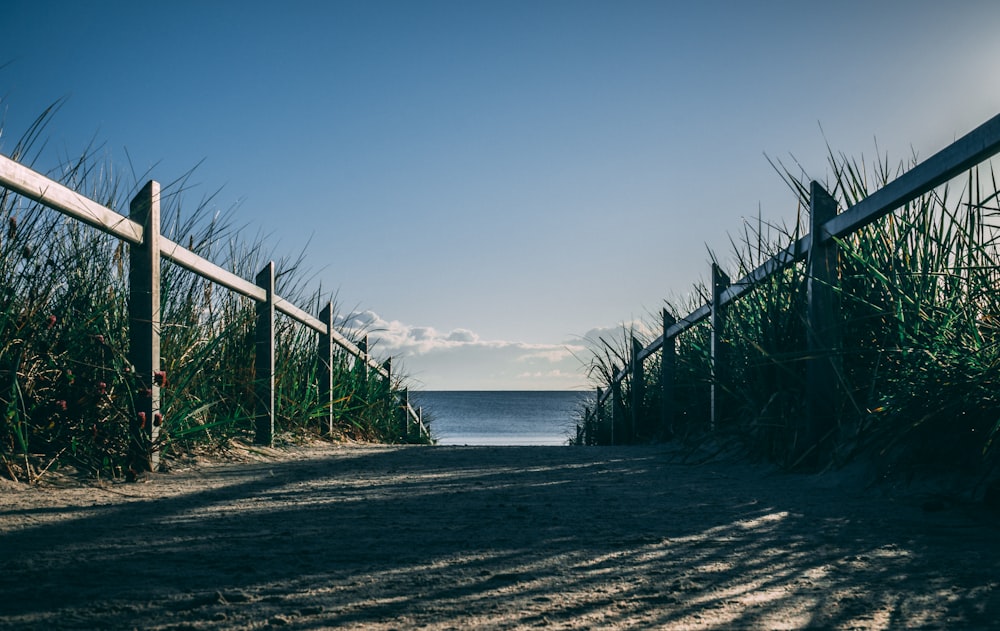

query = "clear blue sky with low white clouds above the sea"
[[0, 0, 1000, 390]]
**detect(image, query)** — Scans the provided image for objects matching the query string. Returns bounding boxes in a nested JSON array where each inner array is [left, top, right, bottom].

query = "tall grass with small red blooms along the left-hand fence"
[[0, 108, 426, 479]]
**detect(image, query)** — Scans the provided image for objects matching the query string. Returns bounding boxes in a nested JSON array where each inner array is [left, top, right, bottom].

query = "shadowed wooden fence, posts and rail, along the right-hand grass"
[[578, 115, 1000, 452]]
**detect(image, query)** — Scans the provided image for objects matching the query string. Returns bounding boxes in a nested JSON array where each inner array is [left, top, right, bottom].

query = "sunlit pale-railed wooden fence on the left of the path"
[[0, 155, 429, 469]]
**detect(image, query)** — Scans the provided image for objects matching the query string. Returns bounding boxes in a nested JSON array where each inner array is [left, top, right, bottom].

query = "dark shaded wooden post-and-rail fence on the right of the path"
[[588, 115, 1000, 456]]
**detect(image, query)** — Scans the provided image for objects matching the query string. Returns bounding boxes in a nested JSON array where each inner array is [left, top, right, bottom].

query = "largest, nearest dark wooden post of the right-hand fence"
[[800, 182, 841, 464]]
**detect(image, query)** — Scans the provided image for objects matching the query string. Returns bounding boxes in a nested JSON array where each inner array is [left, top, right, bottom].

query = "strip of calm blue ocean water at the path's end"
[[410, 391, 593, 445]]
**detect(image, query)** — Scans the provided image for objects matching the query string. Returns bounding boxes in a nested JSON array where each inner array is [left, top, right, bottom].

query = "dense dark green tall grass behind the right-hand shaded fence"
[[581, 147, 1000, 484]]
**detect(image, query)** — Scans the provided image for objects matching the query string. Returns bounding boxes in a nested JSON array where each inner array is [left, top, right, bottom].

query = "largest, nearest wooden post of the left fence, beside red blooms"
[[128, 181, 165, 479]]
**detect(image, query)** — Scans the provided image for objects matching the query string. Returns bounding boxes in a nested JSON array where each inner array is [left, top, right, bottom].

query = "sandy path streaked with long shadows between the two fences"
[[0, 446, 1000, 629]]
